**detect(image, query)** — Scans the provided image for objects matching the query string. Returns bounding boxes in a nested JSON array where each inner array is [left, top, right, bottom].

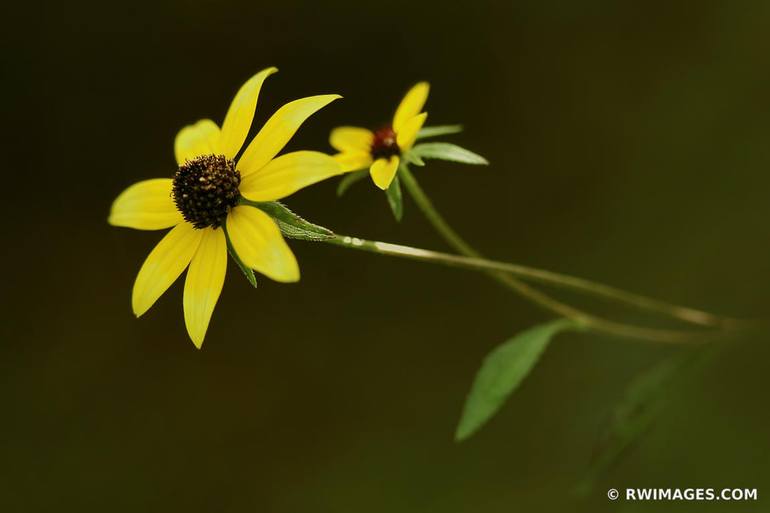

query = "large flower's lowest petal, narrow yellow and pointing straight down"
[[183, 228, 227, 349]]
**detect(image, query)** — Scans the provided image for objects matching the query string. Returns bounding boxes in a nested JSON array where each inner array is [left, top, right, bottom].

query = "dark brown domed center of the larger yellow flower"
[[172, 155, 241, 228]]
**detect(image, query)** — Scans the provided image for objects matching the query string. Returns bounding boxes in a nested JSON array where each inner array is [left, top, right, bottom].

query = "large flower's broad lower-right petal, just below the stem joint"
[[227, 206, 299, 283]]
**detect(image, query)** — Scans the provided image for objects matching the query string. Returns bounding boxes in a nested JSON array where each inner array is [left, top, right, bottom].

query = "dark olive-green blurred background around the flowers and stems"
[[0, 0, 770, 513]]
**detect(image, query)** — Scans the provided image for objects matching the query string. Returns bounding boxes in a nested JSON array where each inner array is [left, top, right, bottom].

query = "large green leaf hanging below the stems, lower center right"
[[455, 319, 579, 442]]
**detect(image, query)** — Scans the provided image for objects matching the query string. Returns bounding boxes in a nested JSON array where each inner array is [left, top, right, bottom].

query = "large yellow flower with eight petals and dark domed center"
[[109, 68, 342, 348]]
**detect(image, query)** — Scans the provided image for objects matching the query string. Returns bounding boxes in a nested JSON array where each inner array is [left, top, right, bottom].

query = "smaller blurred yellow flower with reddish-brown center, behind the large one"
[[329, 82, 430, 190]]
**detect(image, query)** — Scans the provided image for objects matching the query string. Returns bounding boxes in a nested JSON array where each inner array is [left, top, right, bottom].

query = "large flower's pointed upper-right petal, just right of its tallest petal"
[[238, 94, 341, 177]]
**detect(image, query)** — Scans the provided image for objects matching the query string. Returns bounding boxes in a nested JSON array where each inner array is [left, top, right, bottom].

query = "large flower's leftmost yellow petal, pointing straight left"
[[107, 178, 184, 230]]
